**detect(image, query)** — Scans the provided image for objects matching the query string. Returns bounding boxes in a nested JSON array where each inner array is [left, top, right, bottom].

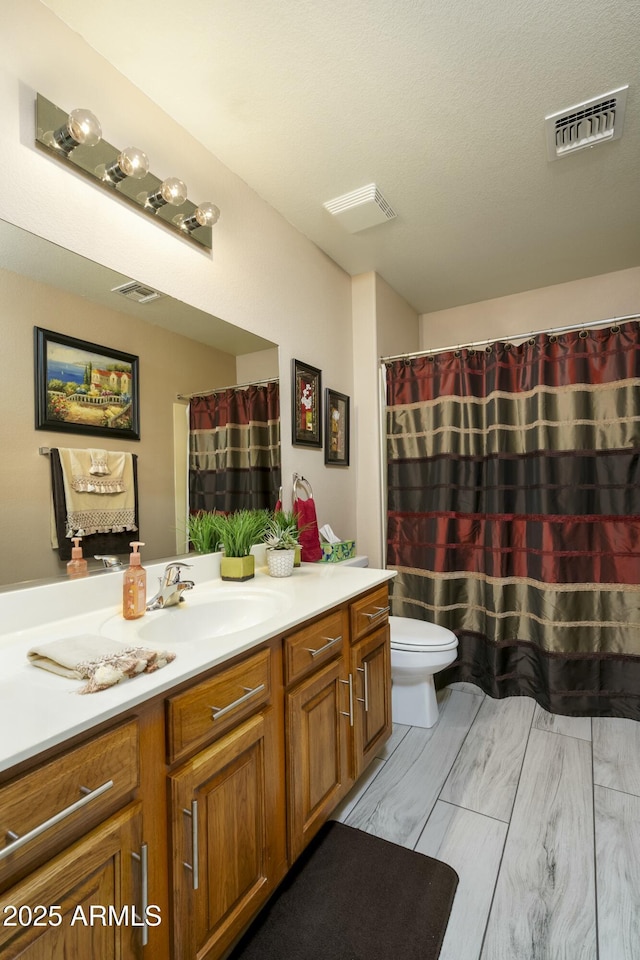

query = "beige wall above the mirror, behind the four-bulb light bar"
[[0, 0, 355, 576]]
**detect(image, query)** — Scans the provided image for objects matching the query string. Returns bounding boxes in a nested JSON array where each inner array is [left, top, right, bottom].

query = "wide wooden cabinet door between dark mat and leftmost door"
[[170, 709, 285, 960]]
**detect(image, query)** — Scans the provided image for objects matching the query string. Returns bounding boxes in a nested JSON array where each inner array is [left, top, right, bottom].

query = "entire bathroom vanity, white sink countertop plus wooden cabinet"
[[0, 558, 393, 960]]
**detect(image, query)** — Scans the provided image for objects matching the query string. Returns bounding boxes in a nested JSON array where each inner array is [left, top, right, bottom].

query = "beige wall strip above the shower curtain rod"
[[420, 267, 640, 350]]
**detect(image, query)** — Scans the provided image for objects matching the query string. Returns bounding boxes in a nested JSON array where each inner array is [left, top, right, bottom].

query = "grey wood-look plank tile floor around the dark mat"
[[335, 684, 640, 960]]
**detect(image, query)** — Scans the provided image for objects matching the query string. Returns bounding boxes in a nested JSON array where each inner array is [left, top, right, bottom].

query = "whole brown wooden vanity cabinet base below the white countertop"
[[0, 586, 391, 960]]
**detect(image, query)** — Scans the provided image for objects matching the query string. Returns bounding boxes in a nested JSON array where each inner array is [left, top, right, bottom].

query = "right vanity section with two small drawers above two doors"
[[284, 586, 391, 862]]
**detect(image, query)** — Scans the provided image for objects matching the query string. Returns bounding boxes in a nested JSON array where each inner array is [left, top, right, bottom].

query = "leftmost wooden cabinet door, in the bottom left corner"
[[0, 805, 145, 960]]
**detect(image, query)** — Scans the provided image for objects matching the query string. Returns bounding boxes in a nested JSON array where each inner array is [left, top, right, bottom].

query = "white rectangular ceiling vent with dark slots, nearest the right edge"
[[544, 84, 629, 160]]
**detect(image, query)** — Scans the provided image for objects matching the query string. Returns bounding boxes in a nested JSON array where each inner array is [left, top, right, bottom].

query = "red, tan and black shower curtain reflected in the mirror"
[[189, 381, 281, 513]]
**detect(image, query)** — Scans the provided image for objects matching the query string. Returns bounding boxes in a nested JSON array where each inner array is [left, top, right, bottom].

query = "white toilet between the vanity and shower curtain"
[[342, 557, 458, 727]]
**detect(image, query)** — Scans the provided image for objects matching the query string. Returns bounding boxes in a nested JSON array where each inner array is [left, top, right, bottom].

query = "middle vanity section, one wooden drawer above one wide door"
[[169, 643, 287, 960]]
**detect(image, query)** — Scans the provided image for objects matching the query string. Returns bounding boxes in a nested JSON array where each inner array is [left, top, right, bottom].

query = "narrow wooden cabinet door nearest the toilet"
[[351, 624, 391, 779]]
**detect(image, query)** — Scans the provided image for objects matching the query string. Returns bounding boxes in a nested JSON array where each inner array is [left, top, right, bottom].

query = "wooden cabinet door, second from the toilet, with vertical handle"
[[286, 658, 352, 861]]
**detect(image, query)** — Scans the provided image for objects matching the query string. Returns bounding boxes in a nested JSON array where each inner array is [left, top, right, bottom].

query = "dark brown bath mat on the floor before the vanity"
[[229, 821, 458, 960]]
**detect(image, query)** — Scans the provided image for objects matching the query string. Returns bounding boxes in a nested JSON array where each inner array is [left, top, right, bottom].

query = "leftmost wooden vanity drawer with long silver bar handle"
[[0, 720, 139, 884]]
